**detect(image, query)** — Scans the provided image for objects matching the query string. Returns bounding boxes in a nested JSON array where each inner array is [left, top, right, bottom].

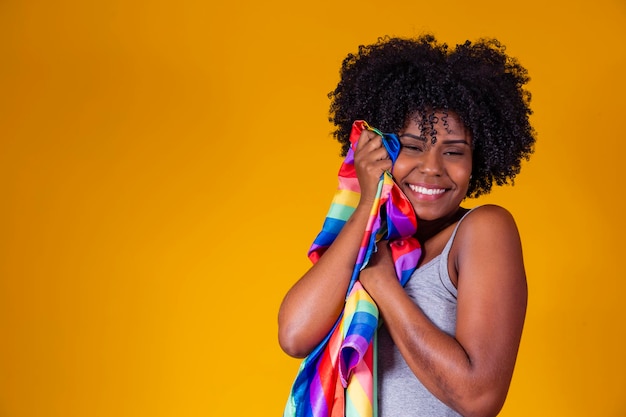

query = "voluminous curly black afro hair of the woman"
[[328, 35, 535, 197]]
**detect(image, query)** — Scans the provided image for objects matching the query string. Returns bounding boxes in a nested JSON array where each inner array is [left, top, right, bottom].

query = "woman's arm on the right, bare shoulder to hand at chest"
[[361, 206, 527, 417]]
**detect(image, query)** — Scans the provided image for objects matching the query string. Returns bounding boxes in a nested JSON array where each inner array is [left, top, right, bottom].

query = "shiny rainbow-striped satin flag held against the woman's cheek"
[[283, 121, 421, 417]]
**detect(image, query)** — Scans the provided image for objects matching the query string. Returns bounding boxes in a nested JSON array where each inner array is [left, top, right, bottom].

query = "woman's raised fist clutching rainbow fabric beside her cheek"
[[354, 130, 392, 207]]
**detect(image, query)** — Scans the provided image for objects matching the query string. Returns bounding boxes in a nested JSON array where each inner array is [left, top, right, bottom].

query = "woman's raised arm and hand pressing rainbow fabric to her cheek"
[[278, 130, 391, 357]]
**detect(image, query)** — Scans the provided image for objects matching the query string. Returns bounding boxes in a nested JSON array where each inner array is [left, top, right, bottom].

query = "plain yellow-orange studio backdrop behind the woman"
[[0, 0, 626, 417]]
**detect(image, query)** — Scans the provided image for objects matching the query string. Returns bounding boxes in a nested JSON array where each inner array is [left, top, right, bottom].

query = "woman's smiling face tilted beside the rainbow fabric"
[[393, 112, 472, 221]]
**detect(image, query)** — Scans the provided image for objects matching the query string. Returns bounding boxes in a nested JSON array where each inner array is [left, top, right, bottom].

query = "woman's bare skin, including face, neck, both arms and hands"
[[279, 113, 527, 416]]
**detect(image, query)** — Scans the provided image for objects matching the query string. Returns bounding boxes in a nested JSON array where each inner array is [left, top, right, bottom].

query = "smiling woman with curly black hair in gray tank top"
[[279, 35, 535, 417]]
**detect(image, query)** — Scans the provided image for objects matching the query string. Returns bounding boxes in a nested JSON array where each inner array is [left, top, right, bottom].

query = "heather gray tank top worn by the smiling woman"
[[378, 210, 471, 417]]
